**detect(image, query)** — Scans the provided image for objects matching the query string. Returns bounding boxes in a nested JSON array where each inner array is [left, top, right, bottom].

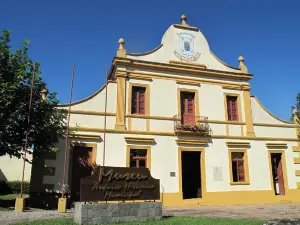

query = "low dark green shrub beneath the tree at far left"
[[0, 181, 30, 194]]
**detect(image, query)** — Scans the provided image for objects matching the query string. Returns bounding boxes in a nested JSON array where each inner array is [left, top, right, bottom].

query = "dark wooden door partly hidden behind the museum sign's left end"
[[71, 146, 93, 201]]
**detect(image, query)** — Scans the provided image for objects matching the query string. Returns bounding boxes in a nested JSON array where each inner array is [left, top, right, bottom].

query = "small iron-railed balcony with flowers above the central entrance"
[[173, 115, 212, 137]]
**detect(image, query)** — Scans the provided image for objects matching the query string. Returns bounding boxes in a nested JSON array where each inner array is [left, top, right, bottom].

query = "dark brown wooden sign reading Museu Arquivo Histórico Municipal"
[[80, 166, 160, 202]]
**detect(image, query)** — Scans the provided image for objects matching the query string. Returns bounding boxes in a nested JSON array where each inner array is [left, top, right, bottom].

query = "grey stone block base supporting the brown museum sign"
[[74, 202, 162, 224]]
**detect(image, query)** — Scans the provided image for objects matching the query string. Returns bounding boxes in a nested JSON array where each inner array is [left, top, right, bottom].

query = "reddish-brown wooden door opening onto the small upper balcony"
[[181, 93, 195, 125]]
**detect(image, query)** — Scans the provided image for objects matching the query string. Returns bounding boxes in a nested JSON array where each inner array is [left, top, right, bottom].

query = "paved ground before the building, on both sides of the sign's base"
[[0, 203, 300, 225]]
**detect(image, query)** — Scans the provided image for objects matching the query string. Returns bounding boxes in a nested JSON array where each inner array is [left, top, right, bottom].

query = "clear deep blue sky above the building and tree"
[[0, 0, 300, 120]]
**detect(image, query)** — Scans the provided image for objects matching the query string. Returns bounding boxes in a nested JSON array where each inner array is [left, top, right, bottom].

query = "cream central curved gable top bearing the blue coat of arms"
[[127, 20, 241, 73]]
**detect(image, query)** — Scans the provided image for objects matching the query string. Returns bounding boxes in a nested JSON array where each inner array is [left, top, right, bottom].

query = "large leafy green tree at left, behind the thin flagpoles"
[[0, 30, 67, 158]]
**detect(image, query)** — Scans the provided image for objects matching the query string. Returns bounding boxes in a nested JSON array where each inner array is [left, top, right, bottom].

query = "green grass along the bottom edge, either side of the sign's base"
[[12, 217, 263, 225]]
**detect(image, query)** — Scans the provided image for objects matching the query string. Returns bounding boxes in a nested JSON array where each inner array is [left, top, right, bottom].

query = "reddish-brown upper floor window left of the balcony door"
[[131, 87, 146, 114]]
